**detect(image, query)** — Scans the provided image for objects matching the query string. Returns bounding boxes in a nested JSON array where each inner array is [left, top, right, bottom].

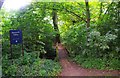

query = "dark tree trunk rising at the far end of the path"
[[52, 9, 60, 44]]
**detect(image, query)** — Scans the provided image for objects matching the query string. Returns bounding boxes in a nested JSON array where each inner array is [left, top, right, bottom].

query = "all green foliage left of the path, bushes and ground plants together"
[[0, 2, 61, 76]]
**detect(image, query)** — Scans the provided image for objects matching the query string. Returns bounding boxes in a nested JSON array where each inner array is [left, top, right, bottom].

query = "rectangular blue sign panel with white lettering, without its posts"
[[10, 30, 22, 44]]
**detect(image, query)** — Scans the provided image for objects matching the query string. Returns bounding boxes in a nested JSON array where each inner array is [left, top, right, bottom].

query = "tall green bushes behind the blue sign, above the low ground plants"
[[1, 3, 55, 57]]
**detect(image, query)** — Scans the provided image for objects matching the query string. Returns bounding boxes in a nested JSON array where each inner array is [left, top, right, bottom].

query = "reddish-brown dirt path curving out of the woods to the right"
[[58, 44, 120, 76]]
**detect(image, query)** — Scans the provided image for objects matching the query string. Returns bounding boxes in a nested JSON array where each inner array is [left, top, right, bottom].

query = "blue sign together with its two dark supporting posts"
[[9, 30, 24, 58]]
